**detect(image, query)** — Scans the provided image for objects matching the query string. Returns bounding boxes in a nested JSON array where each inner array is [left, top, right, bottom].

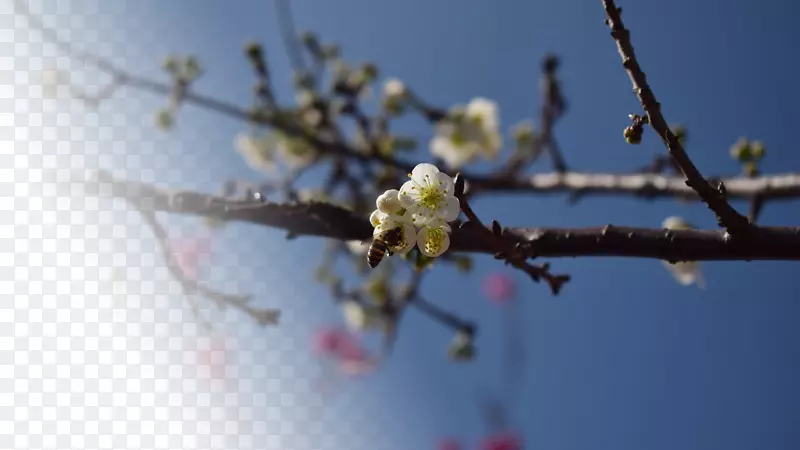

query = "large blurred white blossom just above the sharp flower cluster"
[[430, 97, 503, 169]]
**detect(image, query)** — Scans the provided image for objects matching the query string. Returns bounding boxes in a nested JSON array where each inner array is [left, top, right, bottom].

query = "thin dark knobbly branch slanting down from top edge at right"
[[603, 0, 751, 235]]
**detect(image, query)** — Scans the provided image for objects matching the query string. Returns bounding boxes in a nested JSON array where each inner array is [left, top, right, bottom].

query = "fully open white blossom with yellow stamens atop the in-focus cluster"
[[399, 163, 460, 226]]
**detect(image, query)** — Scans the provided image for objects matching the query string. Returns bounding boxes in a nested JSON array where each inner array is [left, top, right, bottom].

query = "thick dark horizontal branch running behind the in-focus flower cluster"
[[71, 171, 800, 261]]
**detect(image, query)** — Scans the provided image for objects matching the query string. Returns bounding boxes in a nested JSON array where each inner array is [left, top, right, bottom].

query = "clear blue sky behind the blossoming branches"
[[9, 0, 800, 450]]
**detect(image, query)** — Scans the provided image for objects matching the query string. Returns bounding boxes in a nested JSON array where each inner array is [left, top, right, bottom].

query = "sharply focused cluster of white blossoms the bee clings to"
[[369, 163, 460, 258]]
